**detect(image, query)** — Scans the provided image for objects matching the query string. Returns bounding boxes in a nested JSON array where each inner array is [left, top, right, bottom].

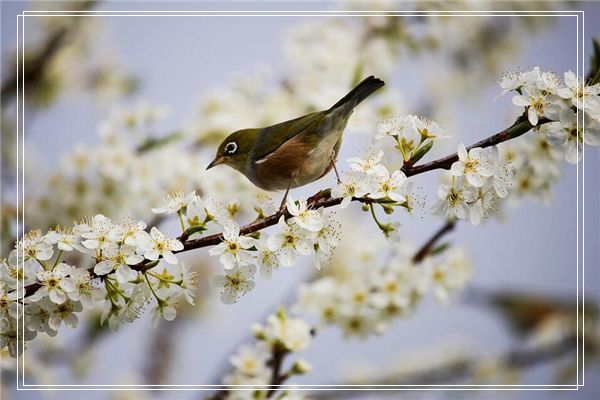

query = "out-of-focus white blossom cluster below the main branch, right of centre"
[[295, 248, 471, 338]]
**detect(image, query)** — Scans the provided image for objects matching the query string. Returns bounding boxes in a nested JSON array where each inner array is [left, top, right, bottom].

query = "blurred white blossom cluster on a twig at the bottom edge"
[[223, 308, 312, 400]]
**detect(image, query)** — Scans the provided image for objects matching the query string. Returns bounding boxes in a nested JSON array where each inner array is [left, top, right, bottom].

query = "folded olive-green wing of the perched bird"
[[254, 112, 324, 162]]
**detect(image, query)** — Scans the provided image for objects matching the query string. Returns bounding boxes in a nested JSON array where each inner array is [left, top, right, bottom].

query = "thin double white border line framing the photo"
[[9, 6, 585, 391]]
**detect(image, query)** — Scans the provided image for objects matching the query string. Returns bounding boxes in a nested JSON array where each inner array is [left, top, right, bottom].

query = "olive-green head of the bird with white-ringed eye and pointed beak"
[[206, 129, 260, 174]]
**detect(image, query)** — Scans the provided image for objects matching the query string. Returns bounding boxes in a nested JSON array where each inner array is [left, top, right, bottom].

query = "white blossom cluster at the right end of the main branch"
[[432, 67, 600, 225]]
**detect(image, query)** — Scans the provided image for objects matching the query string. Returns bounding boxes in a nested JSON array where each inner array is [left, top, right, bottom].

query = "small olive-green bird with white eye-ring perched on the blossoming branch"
[[206, 76, 385, 205]]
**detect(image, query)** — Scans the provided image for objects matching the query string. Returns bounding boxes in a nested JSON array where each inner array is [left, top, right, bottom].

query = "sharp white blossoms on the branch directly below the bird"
[[153, 192, 339, 304]]
